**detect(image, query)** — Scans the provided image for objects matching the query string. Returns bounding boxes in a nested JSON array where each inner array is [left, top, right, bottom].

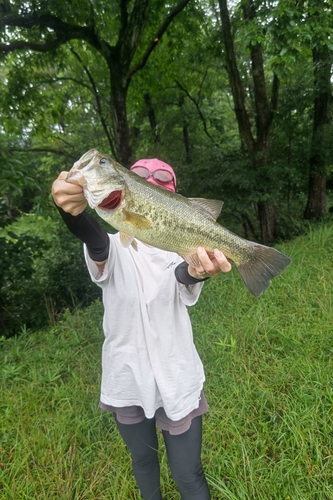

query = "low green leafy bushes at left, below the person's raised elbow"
[[0, 216, 99, 337]]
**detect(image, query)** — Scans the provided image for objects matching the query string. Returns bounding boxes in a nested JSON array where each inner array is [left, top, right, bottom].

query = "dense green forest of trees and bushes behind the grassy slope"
[[0, 0, 333, 337]]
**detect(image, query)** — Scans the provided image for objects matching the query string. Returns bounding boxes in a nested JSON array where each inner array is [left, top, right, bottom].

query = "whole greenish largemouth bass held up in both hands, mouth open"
[[66, 149, 291, 297]]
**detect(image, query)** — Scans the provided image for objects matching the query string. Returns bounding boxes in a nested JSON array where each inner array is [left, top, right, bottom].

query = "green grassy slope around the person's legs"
[[0, 225, 333, 500]]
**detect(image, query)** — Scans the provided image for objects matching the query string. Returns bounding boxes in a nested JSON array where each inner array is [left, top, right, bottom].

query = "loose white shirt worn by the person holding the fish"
[[85, 234, 205, 420]]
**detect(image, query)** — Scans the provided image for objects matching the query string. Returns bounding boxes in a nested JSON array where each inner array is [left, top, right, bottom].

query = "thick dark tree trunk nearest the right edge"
[[304, 45, 332, 219]]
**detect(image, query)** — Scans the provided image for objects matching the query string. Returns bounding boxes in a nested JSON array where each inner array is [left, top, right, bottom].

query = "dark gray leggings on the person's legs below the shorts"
[[116, 416, 210, 500]]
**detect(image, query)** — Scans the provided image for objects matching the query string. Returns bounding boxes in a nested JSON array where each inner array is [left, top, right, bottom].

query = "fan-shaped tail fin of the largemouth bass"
[[237, 241, 291, 297]]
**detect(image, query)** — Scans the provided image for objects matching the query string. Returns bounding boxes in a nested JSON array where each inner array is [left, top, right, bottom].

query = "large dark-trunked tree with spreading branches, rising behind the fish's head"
[[0, 0, 190, 166]]
